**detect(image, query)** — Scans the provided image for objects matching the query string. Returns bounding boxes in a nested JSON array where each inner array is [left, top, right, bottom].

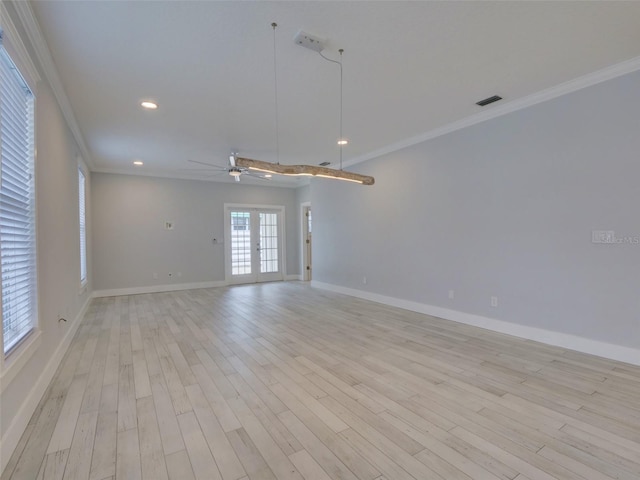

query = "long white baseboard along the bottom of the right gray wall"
[[311, 280, 640, 365]]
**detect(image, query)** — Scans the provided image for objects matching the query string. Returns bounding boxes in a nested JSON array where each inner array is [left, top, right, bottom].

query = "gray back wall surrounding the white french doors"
[[92, 173, 299, 290]]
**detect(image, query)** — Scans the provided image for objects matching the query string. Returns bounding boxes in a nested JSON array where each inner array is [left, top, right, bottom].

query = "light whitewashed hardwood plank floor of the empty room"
[[2, 282, 640, 480]]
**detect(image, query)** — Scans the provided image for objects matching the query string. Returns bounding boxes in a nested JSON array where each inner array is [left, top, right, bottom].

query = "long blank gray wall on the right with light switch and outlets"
[[311, 72, 640, 348]]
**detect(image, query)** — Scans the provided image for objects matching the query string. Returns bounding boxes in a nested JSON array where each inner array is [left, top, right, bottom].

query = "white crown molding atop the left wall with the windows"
[[13, 2, 94, 169]]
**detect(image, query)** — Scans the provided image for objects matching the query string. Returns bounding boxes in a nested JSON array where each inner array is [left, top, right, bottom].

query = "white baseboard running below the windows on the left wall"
[[0, 296, 91, 472]]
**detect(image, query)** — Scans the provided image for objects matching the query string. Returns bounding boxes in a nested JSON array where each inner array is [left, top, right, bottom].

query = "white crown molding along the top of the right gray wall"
[[344, 57, 640, 166]]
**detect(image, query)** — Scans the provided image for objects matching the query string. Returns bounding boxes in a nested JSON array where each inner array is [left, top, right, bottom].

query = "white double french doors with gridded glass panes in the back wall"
[[225, 205, 284, 284]]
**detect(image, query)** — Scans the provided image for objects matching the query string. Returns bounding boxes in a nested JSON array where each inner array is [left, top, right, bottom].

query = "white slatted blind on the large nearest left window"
[[0, 43, 37, 355]]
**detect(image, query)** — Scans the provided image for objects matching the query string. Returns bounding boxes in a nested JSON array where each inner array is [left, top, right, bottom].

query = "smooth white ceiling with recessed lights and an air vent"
[[32, 0, 640, 186]]
